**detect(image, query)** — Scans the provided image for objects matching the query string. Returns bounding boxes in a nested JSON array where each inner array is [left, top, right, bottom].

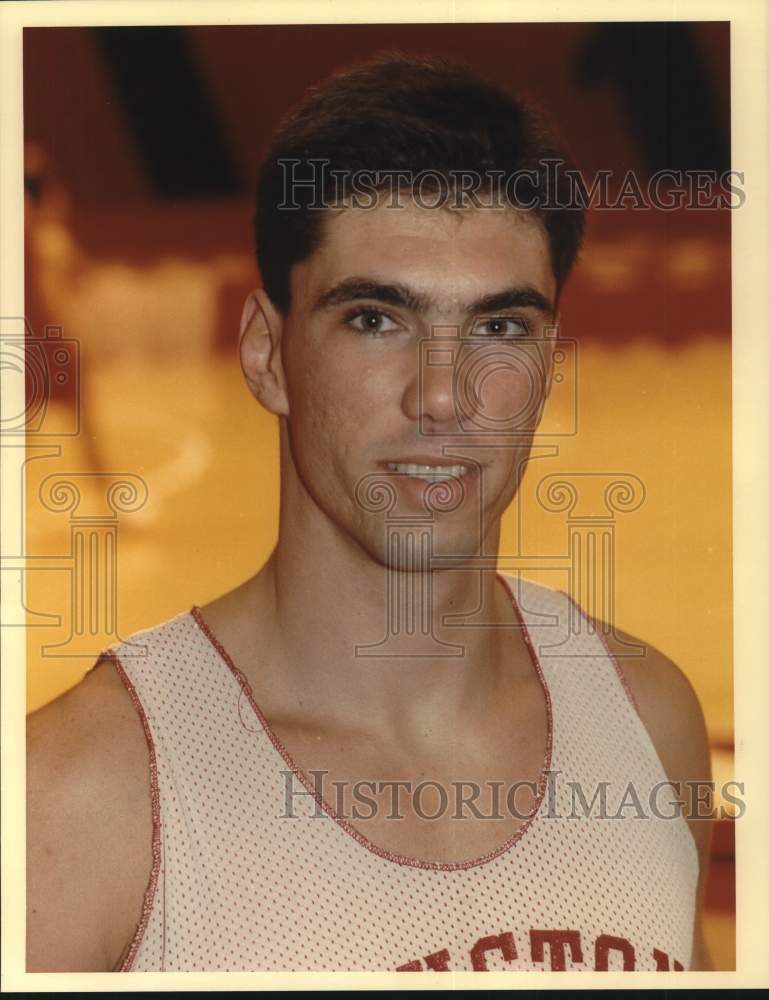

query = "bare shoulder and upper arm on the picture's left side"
[[27, 657, 152, 972]]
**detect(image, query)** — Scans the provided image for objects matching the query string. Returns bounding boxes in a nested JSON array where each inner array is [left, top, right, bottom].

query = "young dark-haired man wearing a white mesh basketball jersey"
[[28, 57, 710, 971]]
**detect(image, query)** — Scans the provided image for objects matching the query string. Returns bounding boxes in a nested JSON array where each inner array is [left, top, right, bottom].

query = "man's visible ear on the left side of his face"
[[240, 288, 288, 417]]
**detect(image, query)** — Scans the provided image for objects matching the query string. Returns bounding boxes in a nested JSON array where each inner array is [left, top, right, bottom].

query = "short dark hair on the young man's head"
[[254, 52, 584, 314]]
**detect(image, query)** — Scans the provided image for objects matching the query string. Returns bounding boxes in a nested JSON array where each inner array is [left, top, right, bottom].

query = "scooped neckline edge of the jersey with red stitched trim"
[[188, 571, 553, 871]]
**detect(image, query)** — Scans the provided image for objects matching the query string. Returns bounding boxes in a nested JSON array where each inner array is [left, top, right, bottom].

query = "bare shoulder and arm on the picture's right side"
[[604, 626, 713, 970]]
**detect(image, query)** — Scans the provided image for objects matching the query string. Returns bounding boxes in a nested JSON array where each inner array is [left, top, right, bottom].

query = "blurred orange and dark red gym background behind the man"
[[24, 22, 735, 969]]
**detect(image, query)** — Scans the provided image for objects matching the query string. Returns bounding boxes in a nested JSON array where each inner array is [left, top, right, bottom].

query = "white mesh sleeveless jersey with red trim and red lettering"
[[107, 574, 699, 972]]
